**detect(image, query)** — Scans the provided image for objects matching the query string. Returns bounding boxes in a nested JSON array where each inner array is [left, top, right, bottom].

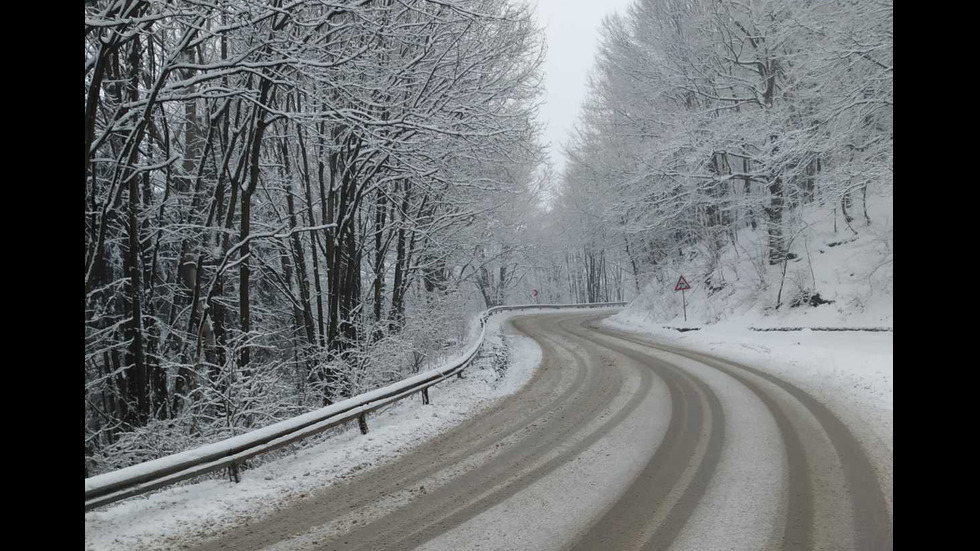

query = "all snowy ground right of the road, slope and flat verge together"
[[603, 190, 894, 507]]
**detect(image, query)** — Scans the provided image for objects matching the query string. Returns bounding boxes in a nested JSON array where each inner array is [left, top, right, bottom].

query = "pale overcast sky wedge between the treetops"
[[531, 0, 632, 175]]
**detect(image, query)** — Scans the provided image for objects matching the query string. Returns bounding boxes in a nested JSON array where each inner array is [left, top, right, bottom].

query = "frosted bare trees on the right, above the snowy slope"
[[557, 0, 893, 306]]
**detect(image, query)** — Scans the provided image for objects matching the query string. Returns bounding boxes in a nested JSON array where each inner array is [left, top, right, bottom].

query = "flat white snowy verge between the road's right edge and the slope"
[[600, 313, 894, 508]]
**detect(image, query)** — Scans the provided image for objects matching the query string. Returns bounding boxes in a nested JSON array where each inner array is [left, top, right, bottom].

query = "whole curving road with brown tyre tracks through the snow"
[[188, 311, 893, 551]]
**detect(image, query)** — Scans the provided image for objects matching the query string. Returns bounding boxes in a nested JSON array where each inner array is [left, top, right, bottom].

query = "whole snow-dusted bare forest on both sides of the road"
[[84, 0, 893, 476]]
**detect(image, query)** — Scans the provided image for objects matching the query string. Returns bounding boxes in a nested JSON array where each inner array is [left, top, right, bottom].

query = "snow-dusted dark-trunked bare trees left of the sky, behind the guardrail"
[[85, 0, 542, 474]]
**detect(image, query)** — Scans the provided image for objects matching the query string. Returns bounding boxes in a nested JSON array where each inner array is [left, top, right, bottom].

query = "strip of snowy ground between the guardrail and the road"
[[85, 312, 541, 551]]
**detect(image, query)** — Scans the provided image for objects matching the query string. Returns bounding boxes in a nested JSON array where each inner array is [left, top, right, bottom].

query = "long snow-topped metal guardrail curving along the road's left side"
[[85, 302, 626, 511]]
